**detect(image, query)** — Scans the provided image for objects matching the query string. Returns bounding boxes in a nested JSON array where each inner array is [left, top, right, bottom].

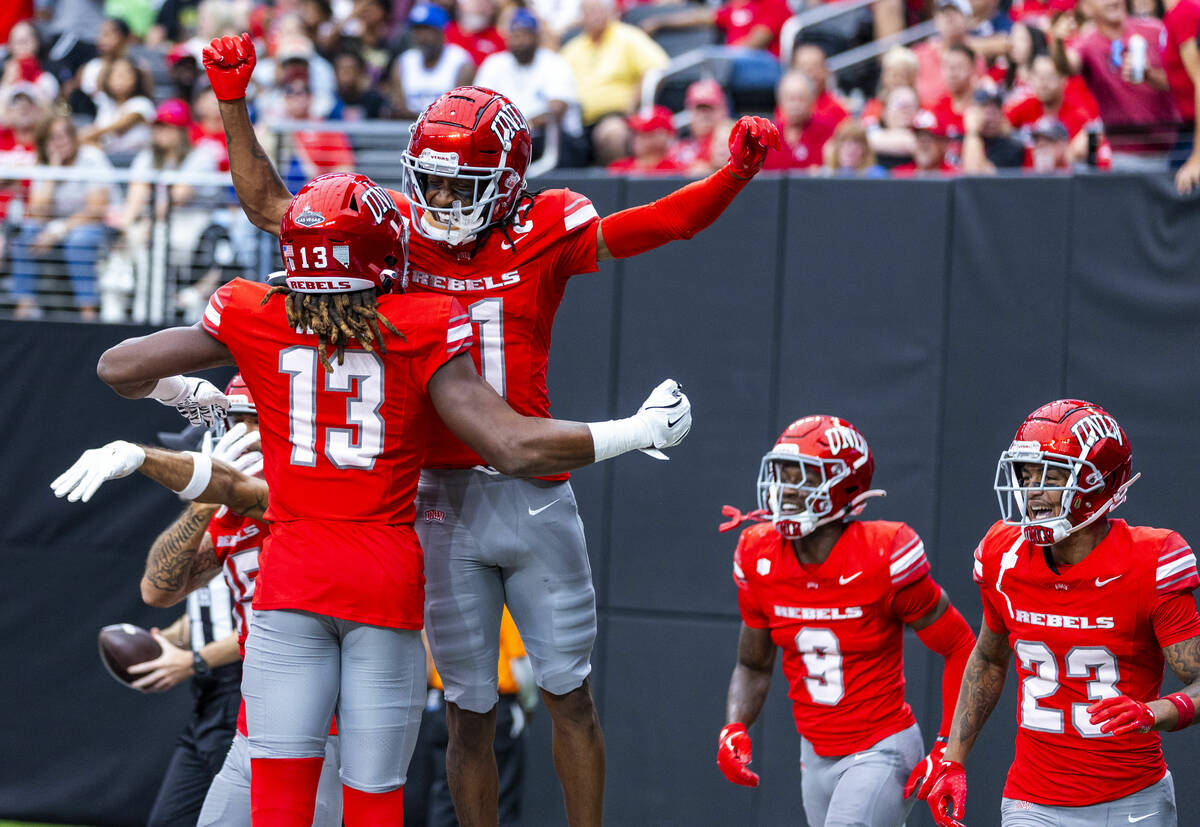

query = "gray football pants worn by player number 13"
[[241, 610, 426, 792]]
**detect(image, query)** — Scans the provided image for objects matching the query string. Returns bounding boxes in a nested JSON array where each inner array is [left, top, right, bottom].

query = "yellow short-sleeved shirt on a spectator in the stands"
[[562, 20, 670, 126]]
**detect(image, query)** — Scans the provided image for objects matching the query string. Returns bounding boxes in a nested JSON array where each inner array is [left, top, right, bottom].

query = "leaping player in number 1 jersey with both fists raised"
[[204, 35, 780, 827]]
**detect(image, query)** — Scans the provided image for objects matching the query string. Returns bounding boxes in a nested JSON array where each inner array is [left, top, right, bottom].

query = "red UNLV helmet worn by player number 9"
[[758, 415, 883, 539]]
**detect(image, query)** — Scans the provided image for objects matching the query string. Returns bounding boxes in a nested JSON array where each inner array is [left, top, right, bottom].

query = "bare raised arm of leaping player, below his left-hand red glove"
[[220, 98, 292, 235]]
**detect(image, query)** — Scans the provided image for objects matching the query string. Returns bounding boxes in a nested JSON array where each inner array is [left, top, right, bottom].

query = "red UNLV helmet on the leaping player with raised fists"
[[402, 86, 533, 246]]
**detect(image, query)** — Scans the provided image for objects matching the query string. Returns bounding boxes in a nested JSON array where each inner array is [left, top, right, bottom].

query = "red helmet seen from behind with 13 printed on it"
[[280, 173, 408, 293]]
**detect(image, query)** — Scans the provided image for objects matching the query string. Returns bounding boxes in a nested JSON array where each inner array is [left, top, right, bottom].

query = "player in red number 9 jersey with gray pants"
[[716, 417, 974, 827]]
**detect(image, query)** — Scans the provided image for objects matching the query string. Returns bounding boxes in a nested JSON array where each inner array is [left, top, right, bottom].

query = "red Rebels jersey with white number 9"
[[733, 521, 941, 756]]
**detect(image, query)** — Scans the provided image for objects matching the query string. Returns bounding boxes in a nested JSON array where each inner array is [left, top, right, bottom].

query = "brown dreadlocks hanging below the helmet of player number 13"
[[262, 284, 407, 372]]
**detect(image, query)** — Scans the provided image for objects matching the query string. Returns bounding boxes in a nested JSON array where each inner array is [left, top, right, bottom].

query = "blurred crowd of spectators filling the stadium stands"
[[0, 0, 1200, 319]]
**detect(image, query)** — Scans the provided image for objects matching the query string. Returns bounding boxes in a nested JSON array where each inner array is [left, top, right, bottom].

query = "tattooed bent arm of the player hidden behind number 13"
[[142, 503, 221, 606]]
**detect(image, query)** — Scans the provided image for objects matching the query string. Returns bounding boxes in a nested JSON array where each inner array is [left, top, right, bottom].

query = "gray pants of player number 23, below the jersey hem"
[[1000, 773, 1178, 827]]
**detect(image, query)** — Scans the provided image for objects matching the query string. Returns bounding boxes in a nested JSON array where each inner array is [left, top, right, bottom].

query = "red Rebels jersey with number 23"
[[974, 520, 1200, 807]]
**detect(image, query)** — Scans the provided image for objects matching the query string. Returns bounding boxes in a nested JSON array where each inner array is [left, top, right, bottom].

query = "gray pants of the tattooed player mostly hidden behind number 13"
[[196, 732, 342, 827]]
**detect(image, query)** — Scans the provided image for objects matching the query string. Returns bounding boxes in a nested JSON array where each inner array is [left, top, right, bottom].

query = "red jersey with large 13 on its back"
[[202, 278, 473, 629]]
